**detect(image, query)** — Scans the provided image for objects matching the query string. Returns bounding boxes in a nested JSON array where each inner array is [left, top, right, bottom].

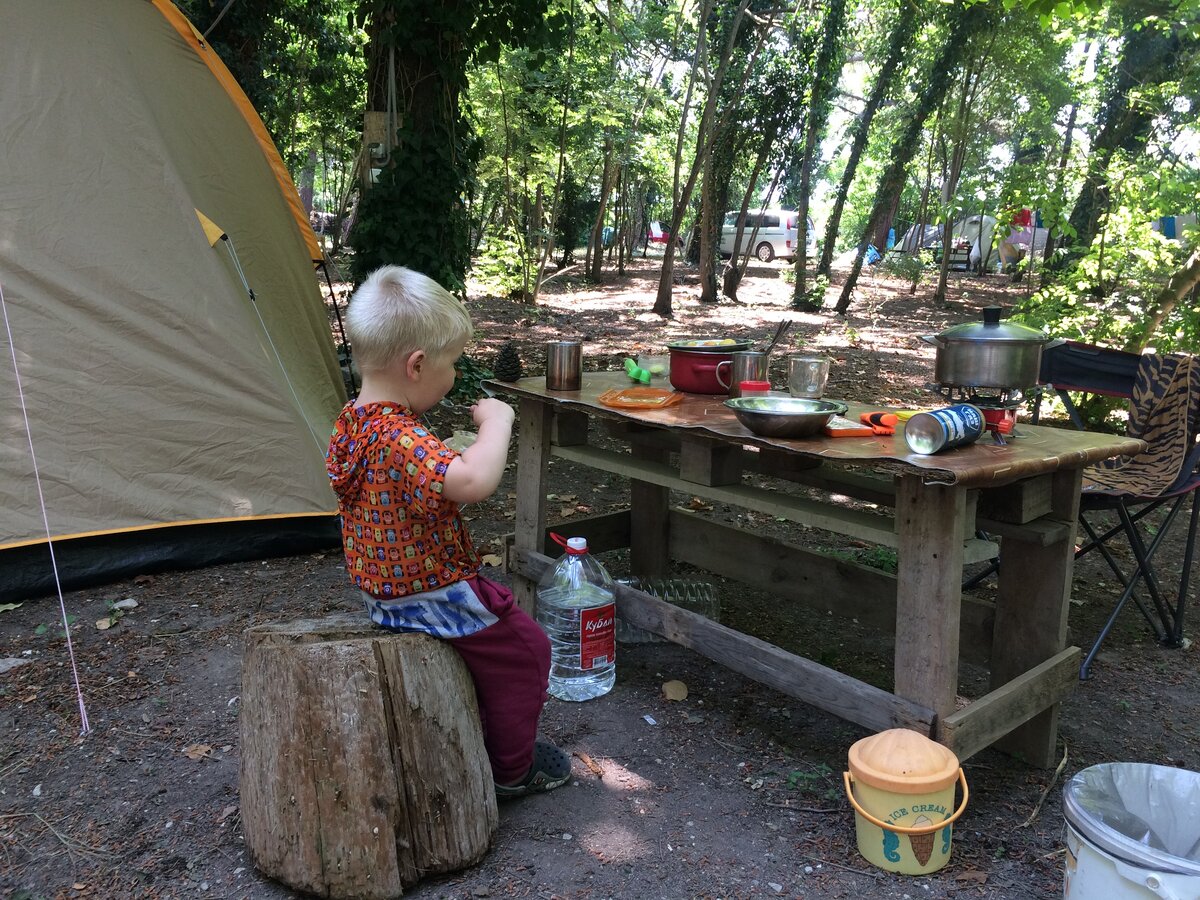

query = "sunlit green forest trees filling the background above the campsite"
[[181, 0, 1200, 350]]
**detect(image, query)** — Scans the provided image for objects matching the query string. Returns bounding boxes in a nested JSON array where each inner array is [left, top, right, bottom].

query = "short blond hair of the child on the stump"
[[346, 265, 474, 368]]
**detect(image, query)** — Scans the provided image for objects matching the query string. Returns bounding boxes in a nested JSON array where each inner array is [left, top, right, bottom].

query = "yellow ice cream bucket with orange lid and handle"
[[842, 728, 967, 875]]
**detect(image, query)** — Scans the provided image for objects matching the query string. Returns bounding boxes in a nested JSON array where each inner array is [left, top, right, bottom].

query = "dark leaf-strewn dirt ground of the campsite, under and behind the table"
[[0, 259, 1200, 900]]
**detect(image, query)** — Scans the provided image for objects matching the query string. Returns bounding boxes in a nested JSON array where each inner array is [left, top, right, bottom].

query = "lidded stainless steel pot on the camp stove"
[[920, 306, 1062, 390]]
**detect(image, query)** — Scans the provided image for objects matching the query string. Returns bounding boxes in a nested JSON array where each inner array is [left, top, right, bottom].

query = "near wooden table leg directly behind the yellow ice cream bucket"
[[895, 475, 966, 718]]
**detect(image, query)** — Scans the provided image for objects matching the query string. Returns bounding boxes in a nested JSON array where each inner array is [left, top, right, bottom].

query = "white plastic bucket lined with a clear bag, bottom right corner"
[[1063, 763, 1200, 900]]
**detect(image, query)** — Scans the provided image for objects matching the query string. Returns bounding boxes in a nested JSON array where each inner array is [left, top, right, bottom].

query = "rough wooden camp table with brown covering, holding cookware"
[[487, 373, 1145, 767]]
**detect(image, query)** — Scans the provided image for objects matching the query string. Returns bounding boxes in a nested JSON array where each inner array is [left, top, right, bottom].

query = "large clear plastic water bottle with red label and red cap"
[[538, 534, 617, 701]]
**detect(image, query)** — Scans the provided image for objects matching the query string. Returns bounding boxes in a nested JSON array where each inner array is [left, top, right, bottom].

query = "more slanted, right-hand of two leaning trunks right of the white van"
[[834, 5, 996, 316]]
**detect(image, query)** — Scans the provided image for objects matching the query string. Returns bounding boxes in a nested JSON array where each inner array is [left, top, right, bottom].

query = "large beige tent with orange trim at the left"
[[0, 0, 344, 600]]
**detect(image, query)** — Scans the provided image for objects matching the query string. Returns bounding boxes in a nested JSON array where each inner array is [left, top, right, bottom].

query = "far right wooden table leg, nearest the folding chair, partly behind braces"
[[991, 469, 1082, 768]]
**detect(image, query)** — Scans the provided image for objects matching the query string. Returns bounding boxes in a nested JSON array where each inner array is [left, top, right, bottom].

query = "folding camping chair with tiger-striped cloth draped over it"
[[1040, 342, 1200, 679]]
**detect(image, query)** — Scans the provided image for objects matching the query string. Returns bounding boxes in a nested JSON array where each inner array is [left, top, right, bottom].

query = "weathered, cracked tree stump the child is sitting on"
[[240, 614, 499, 900]]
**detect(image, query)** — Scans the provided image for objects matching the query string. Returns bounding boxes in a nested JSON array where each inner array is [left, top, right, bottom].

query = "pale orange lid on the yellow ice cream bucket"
[[850, 728, 959, 793]]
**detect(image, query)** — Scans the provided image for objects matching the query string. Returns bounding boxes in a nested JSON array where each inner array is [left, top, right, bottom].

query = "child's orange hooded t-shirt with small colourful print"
[[325, 401, 480, 599]]
